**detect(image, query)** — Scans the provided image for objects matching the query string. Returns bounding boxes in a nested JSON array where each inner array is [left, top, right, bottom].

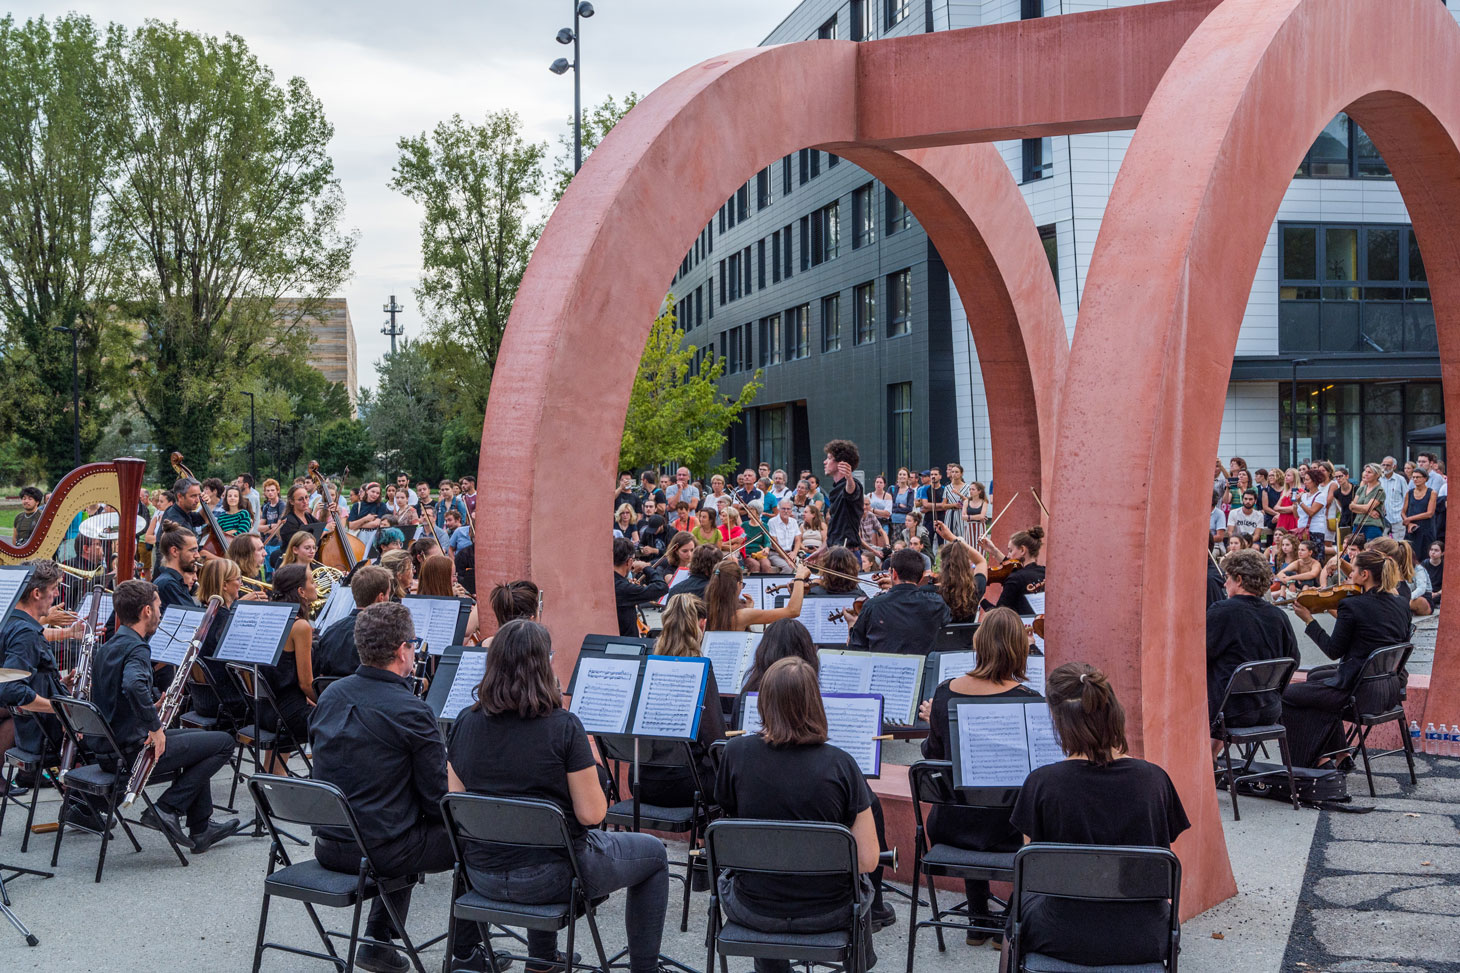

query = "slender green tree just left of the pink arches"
[[390, 111, 546, 424]]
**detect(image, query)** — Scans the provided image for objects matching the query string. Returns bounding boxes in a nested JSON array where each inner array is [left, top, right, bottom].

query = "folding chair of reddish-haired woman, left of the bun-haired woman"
[[908, 760, 1019, 973]]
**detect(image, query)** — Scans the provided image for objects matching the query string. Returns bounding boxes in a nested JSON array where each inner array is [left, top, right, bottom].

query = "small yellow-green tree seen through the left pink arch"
[[618, 295, 761, 469]]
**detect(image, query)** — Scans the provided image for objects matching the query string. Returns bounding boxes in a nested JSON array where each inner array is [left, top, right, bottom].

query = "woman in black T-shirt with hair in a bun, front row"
[[1010, 662, 1191, 966]]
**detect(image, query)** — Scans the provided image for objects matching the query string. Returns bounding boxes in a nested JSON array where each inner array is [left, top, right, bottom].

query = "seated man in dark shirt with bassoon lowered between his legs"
[[92, 581, 238, 853]]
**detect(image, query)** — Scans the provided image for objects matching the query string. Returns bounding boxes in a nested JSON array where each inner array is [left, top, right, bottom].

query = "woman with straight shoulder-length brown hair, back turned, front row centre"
[[715, 659, 877, 973]]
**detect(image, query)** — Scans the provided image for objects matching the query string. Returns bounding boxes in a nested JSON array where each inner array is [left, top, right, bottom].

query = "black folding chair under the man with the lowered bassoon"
[[51, 697, 187, 882]]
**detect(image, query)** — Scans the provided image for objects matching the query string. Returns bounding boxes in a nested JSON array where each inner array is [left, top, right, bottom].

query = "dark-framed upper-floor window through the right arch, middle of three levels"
[[1278, 224, 1440, 355]]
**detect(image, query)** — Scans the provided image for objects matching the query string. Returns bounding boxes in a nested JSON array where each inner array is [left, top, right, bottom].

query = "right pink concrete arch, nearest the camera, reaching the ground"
[[1048, 0, 1460, 915]]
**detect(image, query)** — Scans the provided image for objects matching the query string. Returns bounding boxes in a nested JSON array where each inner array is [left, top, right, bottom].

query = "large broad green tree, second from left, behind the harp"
[[108, 22, 355, 476]]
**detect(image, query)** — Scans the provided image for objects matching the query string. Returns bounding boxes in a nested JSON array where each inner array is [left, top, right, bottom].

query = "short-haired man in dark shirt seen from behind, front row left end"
[[310, 603, 486, 973]]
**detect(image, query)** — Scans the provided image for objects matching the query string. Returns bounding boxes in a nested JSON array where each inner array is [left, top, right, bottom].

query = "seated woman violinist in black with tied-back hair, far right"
[[1282, 549, 1409, 767]]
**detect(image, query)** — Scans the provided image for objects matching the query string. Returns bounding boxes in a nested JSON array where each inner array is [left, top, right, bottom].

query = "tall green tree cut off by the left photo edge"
[[0, 15, 126, 482]]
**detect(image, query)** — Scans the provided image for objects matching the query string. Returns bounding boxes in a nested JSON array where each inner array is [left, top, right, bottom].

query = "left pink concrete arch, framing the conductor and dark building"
[[477, 41, 1066, 676]]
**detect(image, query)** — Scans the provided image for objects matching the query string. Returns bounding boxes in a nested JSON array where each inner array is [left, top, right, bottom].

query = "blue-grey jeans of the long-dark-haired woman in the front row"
[[469, 831, 669, 973]]
